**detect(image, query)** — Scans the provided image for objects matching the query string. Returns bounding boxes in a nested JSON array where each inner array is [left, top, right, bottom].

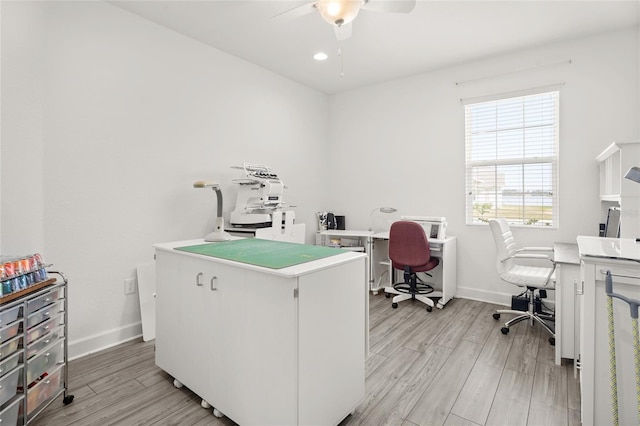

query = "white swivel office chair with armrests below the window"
[[489, 219, 556, 345]]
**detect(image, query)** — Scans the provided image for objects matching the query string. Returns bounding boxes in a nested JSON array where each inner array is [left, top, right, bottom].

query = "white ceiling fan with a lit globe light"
[[274, 0, 416, 40]]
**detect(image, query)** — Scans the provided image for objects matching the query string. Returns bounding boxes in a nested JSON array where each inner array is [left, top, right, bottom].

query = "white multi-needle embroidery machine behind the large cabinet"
[[229, 163, 285, 228]]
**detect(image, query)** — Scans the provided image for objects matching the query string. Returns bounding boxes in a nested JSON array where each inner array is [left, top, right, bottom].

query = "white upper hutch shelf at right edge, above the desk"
[[596, 142, 640, 238]]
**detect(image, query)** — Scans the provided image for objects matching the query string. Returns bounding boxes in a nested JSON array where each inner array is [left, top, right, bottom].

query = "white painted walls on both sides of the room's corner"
[[0, 2, 640, 356]]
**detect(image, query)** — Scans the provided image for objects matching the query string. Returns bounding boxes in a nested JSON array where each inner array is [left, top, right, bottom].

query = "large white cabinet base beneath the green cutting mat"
[[156, 243, 366, 425]]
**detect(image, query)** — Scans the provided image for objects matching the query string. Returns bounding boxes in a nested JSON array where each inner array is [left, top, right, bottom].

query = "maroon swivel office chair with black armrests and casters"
[[384, 220, 440, 312]]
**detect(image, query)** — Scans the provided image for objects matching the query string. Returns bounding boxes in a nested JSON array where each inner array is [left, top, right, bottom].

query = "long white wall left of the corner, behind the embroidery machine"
[[2, 2, 328, 357]]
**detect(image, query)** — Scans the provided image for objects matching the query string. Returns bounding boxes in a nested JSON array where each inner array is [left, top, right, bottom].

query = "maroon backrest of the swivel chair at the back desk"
[[389, 220, 431, 267]]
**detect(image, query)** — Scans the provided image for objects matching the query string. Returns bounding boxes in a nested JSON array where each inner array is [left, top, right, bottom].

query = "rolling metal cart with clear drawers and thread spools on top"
[[0, 264, 73, 426]]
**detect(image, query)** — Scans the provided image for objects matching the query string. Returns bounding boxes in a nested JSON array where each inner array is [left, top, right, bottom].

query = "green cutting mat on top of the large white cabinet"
[[176, 238, 344, 269]]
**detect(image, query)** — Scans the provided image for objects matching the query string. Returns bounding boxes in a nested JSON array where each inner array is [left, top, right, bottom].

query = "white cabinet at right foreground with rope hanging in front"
[[578, 236, 640, 426]]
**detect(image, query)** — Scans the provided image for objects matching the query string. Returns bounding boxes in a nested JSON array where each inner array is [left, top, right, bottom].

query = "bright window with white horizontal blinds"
[[465, 90, 559, 227]]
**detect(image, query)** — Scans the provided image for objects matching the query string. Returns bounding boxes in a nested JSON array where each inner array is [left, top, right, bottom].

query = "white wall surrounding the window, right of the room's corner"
[[330, 29, 640, 303]]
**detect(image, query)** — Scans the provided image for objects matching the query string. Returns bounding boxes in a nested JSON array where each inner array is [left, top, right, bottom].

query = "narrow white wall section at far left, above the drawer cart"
[[0, 2, 46, 255]]
